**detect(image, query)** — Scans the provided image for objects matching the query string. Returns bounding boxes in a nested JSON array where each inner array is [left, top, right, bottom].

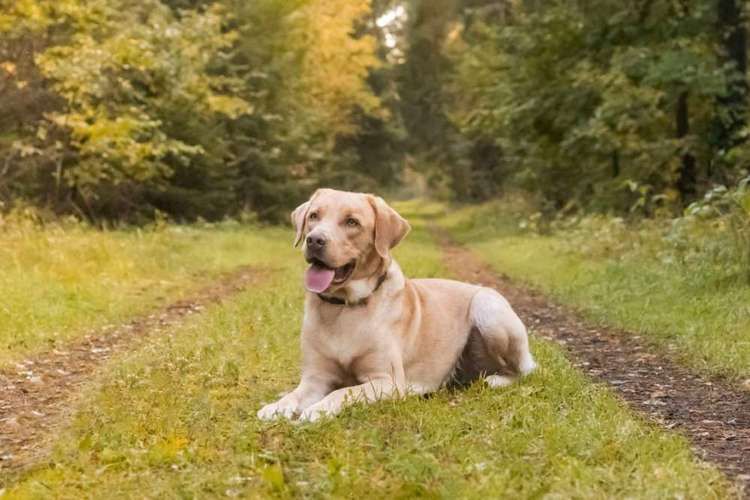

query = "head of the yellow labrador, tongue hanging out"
[[292, 189, 411, 293]]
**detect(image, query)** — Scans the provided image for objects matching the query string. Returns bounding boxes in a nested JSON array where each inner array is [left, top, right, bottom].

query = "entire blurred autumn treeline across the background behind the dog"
[[0, 0, 750, 221]]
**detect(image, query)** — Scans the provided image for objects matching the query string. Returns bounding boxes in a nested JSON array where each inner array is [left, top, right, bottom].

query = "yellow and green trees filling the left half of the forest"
[[0, 0, 397, 220]]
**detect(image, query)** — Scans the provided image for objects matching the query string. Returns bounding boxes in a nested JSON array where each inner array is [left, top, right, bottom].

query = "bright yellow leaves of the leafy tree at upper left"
[[30, 0, 244, 191]]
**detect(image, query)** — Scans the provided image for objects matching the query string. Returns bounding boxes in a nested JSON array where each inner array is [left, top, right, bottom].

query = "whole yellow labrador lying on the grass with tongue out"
[[258, 189, 535, 421]]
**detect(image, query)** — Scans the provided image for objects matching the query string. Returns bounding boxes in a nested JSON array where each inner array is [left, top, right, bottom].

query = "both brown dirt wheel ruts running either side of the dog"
[[0, 231, 750, 496]]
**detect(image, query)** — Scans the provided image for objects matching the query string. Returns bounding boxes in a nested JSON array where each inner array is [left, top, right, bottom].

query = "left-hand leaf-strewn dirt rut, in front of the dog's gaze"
[[0, 267, 263, 476]]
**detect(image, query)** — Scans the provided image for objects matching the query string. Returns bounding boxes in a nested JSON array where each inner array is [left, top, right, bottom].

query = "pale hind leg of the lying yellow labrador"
[[469, 288, 536, 387]]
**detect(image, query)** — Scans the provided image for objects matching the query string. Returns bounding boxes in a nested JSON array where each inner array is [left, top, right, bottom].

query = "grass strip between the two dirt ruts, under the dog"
[[4, 212, 732, 499]]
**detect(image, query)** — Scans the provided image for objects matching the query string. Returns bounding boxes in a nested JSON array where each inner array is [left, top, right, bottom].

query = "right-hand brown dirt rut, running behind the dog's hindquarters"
[[435, 229, 750, 496]]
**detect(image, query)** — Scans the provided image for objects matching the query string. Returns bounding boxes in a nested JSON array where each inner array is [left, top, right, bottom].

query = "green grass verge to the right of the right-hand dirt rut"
[[443, 204, 750, 379]]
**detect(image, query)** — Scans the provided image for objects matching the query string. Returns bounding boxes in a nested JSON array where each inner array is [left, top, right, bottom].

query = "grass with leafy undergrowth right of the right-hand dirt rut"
[[443, 199, 750, 380]]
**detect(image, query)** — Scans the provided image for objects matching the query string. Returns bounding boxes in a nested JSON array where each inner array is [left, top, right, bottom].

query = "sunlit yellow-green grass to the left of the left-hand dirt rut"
[[0, 224, 290, 365]]
